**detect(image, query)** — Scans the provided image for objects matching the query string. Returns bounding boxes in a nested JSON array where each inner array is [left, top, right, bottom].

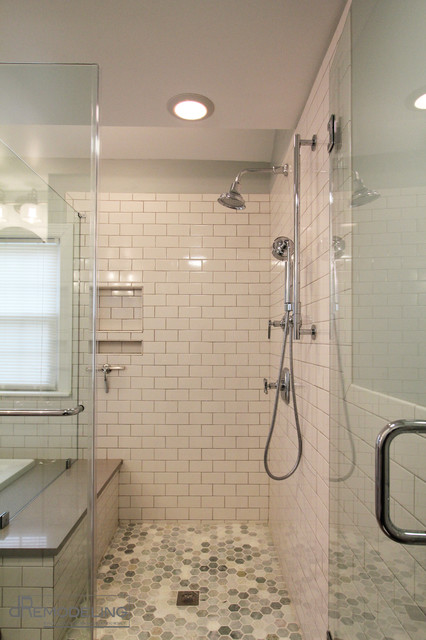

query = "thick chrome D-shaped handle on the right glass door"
[[376, 420, 426, 544]]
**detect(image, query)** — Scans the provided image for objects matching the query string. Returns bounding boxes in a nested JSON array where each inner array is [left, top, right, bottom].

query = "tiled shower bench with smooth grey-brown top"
[[0, 460, 121, 640]]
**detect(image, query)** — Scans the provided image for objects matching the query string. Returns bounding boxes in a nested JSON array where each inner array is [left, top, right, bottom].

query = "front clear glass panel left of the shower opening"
[[0, 64, 98, 640]]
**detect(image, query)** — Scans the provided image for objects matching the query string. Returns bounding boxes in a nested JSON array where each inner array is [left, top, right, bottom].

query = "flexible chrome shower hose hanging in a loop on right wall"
[[263, 311, 303, 480]]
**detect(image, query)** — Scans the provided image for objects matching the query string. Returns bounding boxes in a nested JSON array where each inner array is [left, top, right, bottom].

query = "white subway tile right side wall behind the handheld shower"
[[269, 2, 349, 640]]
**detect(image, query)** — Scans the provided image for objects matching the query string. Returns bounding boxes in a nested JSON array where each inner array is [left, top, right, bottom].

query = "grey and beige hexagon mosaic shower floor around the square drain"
[[68, 522, 302, 640]]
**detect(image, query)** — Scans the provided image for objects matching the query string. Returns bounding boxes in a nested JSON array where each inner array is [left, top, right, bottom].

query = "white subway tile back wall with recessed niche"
[[74, 193, 270, 520]]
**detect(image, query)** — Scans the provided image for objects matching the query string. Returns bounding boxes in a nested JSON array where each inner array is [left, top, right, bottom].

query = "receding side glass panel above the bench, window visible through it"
[[0, 138, 85, 519]]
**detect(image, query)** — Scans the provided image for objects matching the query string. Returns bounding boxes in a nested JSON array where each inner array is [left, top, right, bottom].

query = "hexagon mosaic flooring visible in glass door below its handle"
[[329, 526, 426, 640]]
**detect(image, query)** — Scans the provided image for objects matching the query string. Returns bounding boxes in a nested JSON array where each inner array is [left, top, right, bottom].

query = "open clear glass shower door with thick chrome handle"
[[329, 0, 426, 640]]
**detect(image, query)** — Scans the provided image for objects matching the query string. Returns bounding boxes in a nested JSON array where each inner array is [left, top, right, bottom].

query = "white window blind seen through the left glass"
[[0, 240, 60, 391]]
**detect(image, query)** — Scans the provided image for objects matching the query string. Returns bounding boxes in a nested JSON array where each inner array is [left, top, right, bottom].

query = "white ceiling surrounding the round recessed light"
[[0, 0, 346, 161]]
